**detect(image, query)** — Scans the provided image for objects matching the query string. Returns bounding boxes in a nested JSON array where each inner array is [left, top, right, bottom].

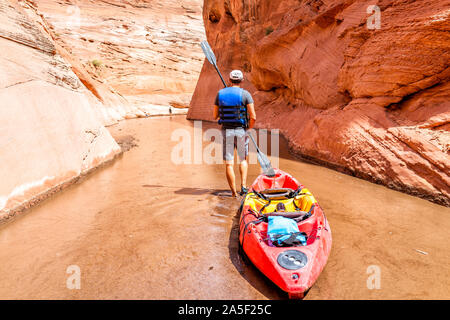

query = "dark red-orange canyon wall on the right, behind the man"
[[188, 0, 450, 205]]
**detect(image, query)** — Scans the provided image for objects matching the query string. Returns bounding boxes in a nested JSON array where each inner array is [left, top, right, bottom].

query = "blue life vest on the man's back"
[[219, 87, 247, 128]]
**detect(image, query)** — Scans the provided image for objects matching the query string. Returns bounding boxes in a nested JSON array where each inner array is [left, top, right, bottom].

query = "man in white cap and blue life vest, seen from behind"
[[213, 70, 256, 197]]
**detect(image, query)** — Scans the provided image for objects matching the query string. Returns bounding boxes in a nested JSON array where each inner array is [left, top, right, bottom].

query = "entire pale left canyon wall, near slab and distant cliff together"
[[0, 0, 204, 220]]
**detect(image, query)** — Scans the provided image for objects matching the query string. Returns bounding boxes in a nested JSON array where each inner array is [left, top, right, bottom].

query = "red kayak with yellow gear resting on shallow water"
[[239, 169, 331, 299]]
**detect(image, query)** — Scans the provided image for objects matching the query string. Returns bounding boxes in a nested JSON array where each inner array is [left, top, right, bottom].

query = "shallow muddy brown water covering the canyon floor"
[[0, 116, 450, 299]]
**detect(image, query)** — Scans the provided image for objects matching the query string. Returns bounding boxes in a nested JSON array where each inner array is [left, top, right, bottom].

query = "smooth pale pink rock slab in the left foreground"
[[0, 0, 120, 222]]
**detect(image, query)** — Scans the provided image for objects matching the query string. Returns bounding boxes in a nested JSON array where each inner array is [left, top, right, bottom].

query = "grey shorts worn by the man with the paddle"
[[222, 128, 249, 161]]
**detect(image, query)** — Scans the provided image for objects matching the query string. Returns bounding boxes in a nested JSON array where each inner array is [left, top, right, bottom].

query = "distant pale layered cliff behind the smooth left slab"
[[27, 0, 205, 117]]
